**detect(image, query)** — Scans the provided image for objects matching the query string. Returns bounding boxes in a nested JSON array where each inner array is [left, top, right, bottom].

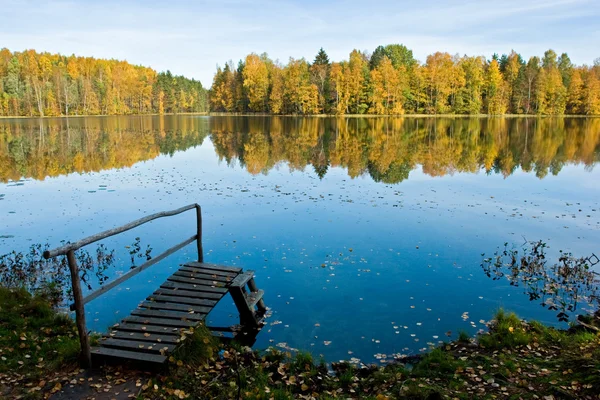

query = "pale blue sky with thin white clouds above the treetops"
[[0, 0, 600, 87]]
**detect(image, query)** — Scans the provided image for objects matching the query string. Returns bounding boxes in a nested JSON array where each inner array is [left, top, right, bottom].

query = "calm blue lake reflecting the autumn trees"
[[0, 115, 600, 362]]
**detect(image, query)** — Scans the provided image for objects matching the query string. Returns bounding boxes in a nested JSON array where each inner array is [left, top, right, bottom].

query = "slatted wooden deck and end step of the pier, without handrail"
[[91, 262, 266, 364]]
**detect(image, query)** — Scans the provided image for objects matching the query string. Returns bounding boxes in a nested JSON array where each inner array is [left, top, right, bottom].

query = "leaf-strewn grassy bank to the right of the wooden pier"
[[144, 310, 600, 400]]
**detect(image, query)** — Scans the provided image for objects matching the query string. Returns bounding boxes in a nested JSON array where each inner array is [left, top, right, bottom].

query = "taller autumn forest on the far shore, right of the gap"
[[210, 44, 600, 115]]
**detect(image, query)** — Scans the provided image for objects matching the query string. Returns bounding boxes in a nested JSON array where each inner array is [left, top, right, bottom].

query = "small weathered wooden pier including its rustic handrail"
[[44, 204, 267, 367]]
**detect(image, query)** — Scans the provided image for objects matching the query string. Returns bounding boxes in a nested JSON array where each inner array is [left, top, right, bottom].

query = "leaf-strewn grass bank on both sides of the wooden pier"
[[0, 288, 600, 400]]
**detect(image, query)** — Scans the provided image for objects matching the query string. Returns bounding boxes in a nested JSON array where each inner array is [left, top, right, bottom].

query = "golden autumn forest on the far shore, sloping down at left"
[[0, 48, 208, 117]]
